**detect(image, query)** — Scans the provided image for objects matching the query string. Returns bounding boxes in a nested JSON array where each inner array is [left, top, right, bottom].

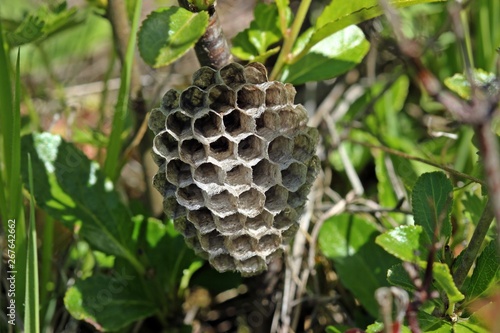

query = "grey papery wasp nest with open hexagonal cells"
[[149, 63, 319, 276]]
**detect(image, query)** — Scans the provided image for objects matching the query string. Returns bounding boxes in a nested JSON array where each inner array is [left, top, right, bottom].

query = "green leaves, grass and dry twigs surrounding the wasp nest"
[[0, 0, 500, 333]]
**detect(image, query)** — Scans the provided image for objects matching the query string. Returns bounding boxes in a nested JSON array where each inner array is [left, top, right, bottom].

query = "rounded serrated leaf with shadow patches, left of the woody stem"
[[138, 7, 208, 68]]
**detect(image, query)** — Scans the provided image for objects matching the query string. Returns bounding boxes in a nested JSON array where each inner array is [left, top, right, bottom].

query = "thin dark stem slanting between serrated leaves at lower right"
[[453, 201, 494, 288]]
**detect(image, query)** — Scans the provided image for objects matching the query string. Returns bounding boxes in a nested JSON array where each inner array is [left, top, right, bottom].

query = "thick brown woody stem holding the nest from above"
[[179, 0, 233, 69]]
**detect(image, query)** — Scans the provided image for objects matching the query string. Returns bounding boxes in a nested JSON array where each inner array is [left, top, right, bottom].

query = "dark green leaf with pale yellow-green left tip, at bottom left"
[[64, 270, 157, 331]]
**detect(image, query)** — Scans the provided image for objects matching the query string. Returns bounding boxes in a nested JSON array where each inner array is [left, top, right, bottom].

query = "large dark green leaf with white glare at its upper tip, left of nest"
[[21, 133, 144, 272]]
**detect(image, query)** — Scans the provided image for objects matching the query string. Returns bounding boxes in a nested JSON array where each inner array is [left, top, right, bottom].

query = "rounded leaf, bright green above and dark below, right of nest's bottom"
[[318, 214, 397, 317]]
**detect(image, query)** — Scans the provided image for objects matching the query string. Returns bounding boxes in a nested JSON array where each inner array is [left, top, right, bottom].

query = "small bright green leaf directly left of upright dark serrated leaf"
[[376, 225, 430, 263]]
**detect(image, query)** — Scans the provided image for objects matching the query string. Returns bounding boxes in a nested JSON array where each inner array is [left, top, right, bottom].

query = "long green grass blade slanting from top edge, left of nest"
[[104, 0, 142, 180]]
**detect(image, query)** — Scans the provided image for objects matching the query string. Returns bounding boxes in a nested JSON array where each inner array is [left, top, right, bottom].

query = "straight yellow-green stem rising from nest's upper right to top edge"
[[269, 0, 312, 80]]
